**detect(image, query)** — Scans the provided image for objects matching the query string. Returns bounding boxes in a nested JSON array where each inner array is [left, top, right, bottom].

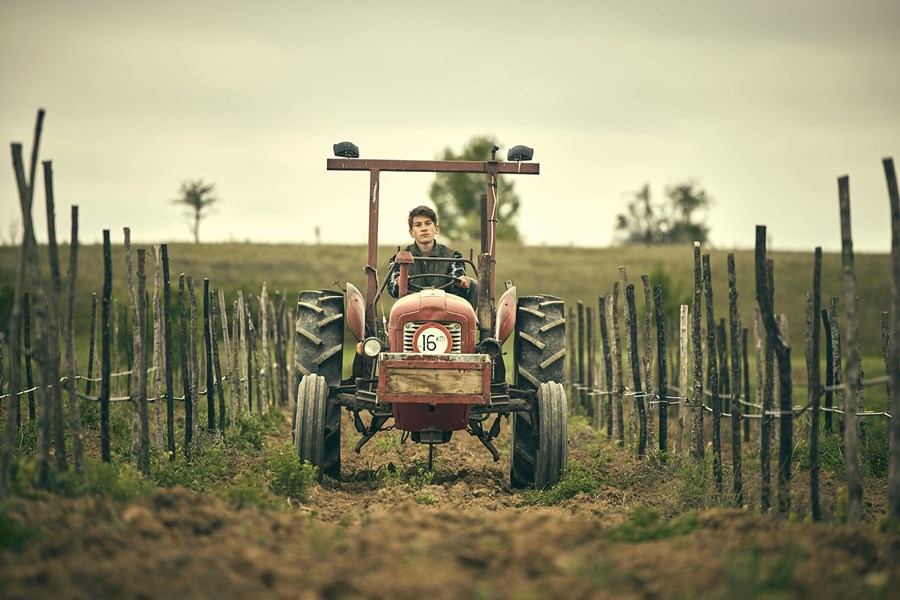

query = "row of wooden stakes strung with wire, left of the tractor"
[[0, 110, 302, 498]]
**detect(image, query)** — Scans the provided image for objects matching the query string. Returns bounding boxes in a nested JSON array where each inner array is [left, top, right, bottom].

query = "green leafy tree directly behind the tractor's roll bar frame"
[[428, 136, 521, 241]]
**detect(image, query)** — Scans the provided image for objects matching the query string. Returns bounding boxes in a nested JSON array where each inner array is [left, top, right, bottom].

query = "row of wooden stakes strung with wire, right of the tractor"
[[567, 158, 900, 521]]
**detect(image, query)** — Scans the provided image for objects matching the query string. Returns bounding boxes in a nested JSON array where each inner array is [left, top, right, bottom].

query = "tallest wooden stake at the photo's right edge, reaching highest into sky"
[[882, 157, 900, 519]]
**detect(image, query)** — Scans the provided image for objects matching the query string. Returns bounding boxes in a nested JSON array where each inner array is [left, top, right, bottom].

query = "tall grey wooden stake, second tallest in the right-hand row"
[[838, 175, 862, 523]]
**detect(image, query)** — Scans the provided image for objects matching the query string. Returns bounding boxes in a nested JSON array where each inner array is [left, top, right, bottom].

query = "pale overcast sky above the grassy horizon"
[[0, 0, 900, 252]]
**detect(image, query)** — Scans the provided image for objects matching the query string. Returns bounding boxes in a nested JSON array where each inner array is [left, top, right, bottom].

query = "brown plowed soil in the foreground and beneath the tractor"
[[0, 418, 900, 600]]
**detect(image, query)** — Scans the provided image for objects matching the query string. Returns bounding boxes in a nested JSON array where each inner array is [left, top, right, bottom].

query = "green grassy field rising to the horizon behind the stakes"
[[0, 243, 890, 358]]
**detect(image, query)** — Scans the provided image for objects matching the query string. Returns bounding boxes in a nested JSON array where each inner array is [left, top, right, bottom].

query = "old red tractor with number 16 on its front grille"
[[293, 142, 568, 489]]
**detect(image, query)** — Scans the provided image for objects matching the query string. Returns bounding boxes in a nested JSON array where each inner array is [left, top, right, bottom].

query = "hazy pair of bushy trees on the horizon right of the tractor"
[[616, 181, 712, 245]]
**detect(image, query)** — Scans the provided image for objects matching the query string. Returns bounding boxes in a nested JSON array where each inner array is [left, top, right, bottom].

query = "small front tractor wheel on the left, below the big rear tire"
[[294, 374, 341, 481]]
